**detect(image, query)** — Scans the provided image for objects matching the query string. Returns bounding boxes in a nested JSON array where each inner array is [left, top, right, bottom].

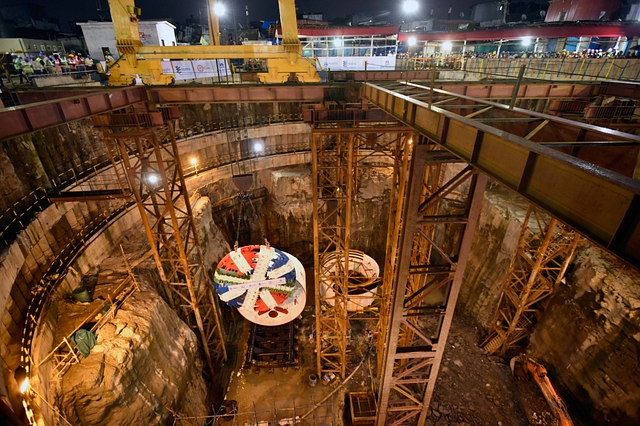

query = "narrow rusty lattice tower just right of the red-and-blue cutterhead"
[[311, 130, 357, 378]]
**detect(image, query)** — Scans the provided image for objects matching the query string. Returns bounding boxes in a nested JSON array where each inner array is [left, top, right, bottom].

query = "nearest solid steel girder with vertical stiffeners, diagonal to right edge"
[[364, 84, 640, 269]]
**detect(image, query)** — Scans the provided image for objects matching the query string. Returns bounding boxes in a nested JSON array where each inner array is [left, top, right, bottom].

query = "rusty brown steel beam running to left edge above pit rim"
[[0, 86, 147, 140]]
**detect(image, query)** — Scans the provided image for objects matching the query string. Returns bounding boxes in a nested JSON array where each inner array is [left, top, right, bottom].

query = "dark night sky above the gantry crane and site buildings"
[[18, 0, 486, 31]]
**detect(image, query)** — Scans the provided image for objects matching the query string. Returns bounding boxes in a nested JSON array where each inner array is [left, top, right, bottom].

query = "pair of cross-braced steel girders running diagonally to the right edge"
[[364, 83, 640, 267]]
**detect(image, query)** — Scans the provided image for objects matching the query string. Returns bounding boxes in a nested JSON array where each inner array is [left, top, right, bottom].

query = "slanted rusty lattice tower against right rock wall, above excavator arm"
[[481, 205, 580, 356]]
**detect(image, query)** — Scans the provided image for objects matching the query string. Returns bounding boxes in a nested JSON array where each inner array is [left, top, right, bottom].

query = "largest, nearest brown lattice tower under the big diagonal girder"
[[376, 140, 487, 425]]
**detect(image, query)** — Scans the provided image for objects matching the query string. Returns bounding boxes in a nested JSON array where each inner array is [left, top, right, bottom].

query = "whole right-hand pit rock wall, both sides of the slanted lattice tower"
[[457, 186, 640, 425]]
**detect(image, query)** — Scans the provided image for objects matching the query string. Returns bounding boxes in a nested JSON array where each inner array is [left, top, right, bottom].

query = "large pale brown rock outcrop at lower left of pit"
[[59, 282, 207, 425]]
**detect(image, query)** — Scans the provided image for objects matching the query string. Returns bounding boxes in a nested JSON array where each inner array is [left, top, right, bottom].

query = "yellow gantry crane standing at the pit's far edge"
[[109, 0, 320, 86]]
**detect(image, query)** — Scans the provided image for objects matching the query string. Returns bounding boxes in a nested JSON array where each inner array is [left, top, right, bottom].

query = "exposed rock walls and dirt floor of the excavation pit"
[[15, 120, 640, 426]]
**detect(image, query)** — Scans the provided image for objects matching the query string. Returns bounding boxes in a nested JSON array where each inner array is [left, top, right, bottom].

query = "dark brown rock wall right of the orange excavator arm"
[[528, 243, 640, 425]]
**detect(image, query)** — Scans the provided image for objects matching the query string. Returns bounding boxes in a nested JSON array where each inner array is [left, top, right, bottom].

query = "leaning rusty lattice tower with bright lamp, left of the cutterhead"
[[104, 115, 227, 377]]
